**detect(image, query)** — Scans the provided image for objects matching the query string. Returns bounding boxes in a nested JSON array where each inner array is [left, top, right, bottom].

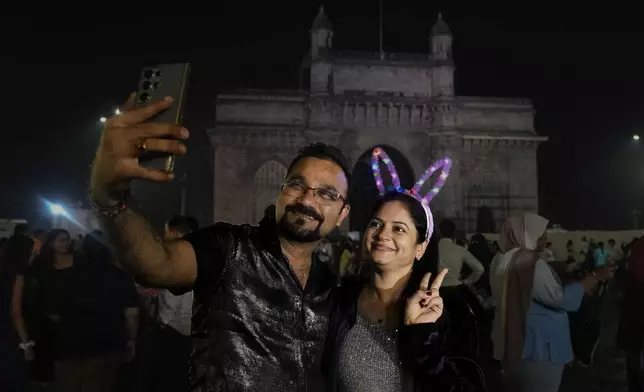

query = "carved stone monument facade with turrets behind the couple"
[[209, 9, 546, 231]]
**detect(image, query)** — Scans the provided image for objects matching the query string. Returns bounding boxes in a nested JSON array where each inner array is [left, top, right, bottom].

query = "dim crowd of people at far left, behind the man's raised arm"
[[0, 216, 198, 391]]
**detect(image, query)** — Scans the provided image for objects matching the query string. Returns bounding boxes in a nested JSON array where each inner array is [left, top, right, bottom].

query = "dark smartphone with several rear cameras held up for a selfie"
[[135, 63, 190, 172]]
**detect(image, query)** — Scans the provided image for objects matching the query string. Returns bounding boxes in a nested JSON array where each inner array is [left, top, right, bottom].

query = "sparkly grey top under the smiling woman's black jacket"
[[337, 312, 413, 392]]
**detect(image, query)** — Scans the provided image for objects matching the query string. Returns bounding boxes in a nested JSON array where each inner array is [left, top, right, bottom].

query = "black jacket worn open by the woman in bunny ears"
[[322, 282, 476, 392]]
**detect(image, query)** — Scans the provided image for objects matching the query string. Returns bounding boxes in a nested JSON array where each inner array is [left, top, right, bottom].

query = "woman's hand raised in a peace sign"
[[405, 268, 447, 325]]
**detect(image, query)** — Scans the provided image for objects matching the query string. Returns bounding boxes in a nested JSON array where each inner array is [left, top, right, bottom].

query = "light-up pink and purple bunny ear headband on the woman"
[[371, 147, 452, 241]]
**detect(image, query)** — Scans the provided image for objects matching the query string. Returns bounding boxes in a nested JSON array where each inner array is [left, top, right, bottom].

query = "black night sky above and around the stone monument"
[[0, 1, 644, 229]]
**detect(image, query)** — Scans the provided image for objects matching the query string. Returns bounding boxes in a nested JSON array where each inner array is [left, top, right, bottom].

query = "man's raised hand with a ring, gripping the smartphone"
[[90, 94, 189, 207]]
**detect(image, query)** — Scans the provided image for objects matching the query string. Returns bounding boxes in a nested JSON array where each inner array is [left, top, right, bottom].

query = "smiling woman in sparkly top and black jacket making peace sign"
[[323, 192, 472, 392]]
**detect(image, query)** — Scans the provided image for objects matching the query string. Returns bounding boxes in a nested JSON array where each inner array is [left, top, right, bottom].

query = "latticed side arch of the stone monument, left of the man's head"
[[251, 161, 286, 223]]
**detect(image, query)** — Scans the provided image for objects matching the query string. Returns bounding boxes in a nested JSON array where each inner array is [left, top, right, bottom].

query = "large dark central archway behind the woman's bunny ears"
[[349, 145, 416, 233]]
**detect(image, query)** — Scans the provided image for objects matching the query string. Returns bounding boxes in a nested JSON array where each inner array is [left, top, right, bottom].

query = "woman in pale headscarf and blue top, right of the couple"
[[490, 214, 613, 392]]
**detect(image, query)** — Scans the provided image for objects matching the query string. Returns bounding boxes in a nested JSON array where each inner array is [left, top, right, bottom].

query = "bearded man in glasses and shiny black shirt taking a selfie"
[[90, 97, 350, 392]]
